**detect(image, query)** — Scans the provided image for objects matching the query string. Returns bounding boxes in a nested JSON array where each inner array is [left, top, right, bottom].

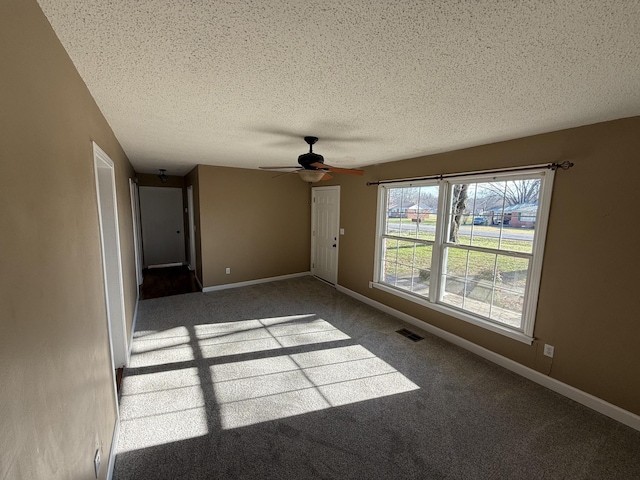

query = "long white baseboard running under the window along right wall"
[[336, 285, 640, 431]]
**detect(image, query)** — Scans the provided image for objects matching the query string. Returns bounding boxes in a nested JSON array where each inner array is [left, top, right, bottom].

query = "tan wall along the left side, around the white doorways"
[[0, 0, 136, 479]]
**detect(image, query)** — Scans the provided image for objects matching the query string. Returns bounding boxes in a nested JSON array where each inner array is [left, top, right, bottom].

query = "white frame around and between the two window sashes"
[[371, 165, 555, 345]]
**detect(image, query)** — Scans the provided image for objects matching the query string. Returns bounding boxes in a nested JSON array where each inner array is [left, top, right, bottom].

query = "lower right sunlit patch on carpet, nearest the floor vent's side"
[[210, 345, 419, 429]]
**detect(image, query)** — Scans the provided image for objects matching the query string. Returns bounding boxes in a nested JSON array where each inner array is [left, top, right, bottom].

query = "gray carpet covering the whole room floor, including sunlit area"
[[114, 277, 640, 480]]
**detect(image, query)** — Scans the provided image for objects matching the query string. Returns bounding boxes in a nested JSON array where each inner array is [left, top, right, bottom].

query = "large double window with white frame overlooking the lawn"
[[374, 169, 554, 343]]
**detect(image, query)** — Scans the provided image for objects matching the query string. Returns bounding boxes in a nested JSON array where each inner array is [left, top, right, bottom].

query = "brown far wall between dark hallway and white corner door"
[[198, 165, 311, 287]]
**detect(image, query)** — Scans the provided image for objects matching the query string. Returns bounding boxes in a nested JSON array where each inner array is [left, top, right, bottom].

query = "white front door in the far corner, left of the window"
[[311, 186, 340, 285]]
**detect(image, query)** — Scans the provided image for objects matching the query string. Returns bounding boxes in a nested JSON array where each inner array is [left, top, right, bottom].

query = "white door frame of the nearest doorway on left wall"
[[92, 142, 129, 370]]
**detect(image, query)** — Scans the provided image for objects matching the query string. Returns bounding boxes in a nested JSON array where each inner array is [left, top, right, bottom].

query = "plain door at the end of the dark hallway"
[[139, 187, 185, 267]]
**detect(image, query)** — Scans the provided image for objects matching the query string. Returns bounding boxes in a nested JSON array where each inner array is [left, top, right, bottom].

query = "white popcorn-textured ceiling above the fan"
[[38, 0, 640, 175]]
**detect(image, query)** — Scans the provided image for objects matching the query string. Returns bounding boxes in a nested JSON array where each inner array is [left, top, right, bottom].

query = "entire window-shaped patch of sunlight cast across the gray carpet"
[[119, 314, 419, 446]]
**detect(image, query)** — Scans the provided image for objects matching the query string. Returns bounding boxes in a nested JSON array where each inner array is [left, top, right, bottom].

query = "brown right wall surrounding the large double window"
[[336, 117, 640, 414]]
